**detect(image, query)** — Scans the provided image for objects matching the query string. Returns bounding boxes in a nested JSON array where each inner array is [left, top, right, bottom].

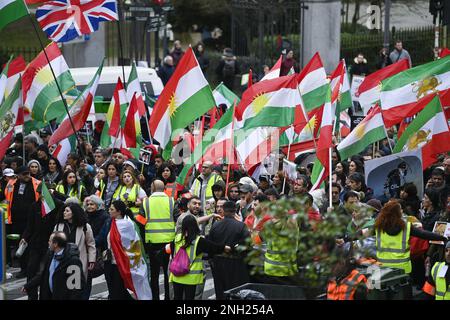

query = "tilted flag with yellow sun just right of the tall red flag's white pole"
[[337, 105, 386, 159]]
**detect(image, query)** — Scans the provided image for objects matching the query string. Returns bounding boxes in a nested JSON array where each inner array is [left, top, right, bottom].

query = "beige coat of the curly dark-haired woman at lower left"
[[54, 223, 97, 277]]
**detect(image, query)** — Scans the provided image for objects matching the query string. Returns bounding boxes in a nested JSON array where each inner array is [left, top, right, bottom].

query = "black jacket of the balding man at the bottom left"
[[25, 243, 86, 300]]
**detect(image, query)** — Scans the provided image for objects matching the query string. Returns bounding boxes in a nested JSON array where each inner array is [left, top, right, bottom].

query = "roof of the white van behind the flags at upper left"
[[70, 66, 164, 96]]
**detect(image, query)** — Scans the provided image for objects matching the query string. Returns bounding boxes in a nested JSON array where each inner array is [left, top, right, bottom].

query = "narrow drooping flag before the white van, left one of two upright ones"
[[100, 77, 128, 148]]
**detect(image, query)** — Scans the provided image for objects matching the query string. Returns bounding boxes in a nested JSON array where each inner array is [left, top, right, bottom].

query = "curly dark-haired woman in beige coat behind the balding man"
[[54, 203, 96, 300]]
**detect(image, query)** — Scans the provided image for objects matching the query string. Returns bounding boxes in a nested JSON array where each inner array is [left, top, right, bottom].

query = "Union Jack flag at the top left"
[[36, 0, 118, 42]]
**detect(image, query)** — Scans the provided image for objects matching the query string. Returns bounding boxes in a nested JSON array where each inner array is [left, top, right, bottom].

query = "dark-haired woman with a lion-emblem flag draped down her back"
[[102, 200, 152, 300]]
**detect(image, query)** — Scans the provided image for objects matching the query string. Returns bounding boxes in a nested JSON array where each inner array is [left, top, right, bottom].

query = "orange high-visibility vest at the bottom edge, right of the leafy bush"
[[327, 269, 367, 300]]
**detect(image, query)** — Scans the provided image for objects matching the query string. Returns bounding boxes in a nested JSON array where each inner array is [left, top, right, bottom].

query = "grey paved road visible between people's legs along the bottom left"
[[4, 268, 215, 300]]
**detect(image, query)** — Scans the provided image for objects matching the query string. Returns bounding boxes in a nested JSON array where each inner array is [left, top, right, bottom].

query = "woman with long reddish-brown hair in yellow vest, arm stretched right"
[[374, 200, 447, 280]]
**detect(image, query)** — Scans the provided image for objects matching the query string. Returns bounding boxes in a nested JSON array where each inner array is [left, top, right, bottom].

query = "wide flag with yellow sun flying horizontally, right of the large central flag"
[[236, 74, 306, 129]]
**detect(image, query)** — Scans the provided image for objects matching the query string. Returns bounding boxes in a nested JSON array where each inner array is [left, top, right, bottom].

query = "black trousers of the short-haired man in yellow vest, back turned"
[[144, 243, 170, 300]]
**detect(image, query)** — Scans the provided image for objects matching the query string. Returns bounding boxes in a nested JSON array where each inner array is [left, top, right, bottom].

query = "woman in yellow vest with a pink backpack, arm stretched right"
[[170, 215, 231, 300]]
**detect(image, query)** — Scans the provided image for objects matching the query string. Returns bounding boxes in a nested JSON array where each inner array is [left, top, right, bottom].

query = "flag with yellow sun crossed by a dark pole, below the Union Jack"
[[22, 42, 75, 121]]
